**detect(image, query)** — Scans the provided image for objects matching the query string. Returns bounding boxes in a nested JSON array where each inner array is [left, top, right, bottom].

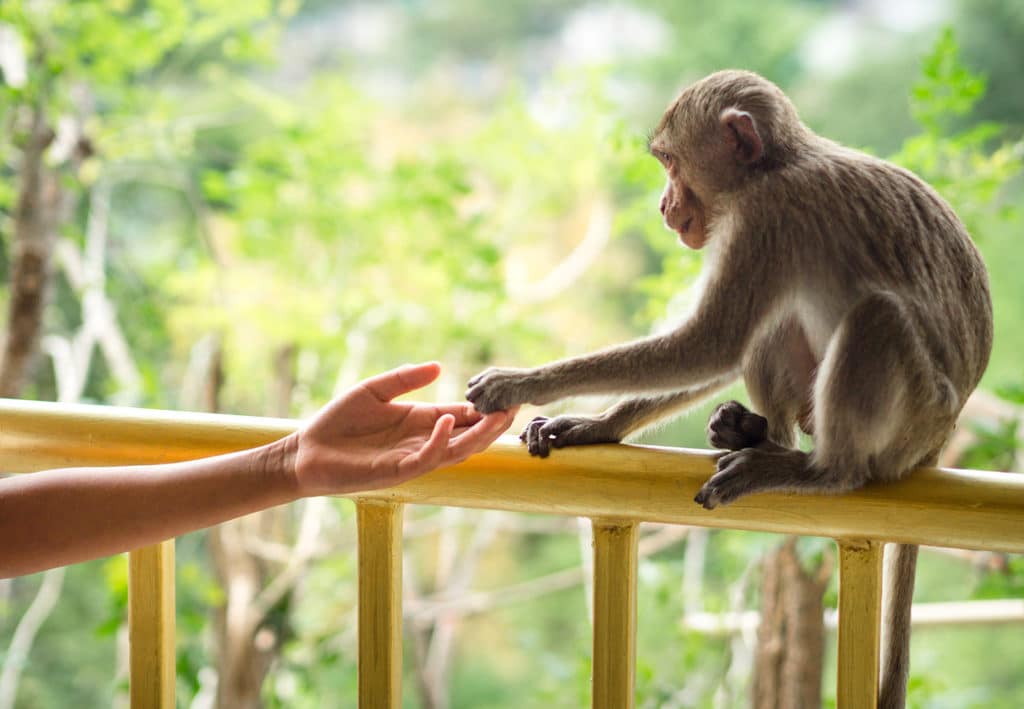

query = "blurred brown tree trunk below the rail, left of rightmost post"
[[752, 537, 831, 709]]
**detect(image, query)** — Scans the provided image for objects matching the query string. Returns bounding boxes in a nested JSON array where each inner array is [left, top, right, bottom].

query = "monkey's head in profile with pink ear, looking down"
[[648, 71, 808, 249]]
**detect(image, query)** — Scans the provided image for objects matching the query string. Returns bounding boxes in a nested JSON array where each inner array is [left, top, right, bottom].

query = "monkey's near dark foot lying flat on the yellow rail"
[[693, 447, 811, 509]]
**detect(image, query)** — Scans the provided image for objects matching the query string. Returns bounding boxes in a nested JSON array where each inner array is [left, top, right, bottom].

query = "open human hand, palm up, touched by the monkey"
[[290, 363, 516, 497]]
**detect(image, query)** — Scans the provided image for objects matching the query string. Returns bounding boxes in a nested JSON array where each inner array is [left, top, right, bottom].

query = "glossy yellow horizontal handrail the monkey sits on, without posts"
[[0, 400, 1024, 552]]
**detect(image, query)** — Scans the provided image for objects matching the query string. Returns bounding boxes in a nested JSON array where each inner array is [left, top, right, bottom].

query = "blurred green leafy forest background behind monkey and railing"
[[0, 0, 1024, 709]]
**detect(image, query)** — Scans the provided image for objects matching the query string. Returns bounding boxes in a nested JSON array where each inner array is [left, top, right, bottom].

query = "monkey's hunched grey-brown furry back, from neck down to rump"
[[759, 144, 992, 395]]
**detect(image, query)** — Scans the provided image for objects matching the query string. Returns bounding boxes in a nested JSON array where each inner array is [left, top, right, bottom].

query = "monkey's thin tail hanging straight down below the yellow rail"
[[879, 544, 918, 709]]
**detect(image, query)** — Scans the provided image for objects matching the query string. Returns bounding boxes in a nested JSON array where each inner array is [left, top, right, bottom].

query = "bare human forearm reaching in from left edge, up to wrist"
[[0, 436, 298, 578]]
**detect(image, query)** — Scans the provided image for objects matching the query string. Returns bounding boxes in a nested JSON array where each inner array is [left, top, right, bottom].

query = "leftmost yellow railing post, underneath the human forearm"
[[128, 539, 177, 709]]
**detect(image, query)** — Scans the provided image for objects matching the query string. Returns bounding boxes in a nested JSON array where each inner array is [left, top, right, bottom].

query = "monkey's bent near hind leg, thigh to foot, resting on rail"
[[694, 293, 957, 509]]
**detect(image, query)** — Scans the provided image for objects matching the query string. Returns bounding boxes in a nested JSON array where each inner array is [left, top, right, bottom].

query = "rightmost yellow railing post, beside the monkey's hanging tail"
[[836, 540, 883, 709]]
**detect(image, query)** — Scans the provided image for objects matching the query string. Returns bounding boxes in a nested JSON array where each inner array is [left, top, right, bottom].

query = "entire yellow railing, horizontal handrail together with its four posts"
[[0, 400, 1024, 709]]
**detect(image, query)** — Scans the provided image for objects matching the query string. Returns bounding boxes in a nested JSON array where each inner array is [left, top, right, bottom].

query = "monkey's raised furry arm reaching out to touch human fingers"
[[466, 249, 781, 413]]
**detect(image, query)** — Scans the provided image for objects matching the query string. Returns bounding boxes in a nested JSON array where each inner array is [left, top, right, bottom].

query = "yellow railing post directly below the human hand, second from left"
[[355, 500, 402, 709]]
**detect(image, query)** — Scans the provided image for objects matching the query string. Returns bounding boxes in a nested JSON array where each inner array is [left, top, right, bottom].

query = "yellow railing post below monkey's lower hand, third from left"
[[592, 519, 638, 709]]
